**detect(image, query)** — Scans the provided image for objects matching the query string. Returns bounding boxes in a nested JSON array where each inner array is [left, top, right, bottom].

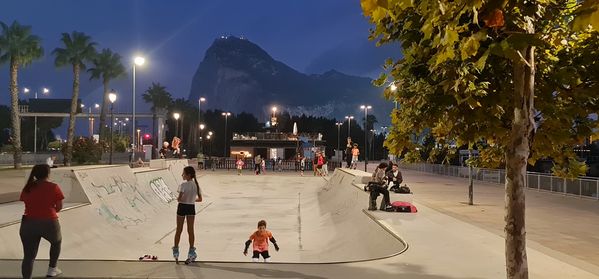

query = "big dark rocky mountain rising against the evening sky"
[[189, 36, 393, 124]]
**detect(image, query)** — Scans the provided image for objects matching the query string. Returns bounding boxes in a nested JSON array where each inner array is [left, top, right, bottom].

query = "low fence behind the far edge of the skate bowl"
[[199, 158, 341, 171]]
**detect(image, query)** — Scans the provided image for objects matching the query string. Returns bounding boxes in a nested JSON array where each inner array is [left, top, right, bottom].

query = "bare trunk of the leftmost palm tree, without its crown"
[[9, 59, 23, 169]]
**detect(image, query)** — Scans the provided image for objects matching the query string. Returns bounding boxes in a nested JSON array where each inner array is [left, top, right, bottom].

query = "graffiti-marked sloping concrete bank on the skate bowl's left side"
[[0, 161, 192, 260]]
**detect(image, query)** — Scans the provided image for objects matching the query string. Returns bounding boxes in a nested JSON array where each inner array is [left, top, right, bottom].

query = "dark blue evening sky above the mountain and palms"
[[0, 0, 399, 137]]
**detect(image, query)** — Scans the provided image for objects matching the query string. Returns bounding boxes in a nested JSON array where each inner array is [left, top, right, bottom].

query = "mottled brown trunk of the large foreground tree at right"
[[505, 19, 535, 279]]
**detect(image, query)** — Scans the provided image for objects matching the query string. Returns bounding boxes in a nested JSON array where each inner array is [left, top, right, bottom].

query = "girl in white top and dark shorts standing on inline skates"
[[173, 166, 202, 264]]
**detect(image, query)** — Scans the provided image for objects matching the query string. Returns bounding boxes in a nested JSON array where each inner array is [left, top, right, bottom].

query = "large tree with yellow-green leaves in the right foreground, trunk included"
[[361, 0, 599, 278]]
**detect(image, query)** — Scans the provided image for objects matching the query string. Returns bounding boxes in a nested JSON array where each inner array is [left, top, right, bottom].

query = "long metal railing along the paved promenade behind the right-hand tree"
[[400, 163, 599, 200]]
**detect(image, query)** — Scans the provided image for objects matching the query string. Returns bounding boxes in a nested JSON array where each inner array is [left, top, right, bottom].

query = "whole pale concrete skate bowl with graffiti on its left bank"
[[0, 166, 407, 263]]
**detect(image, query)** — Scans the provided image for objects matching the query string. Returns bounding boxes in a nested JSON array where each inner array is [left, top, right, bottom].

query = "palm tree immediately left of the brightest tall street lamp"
[[87, 48, 125, 141]]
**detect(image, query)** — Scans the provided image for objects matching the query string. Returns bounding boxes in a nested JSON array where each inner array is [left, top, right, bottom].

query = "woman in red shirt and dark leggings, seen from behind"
[[19, 164, 64, 278]]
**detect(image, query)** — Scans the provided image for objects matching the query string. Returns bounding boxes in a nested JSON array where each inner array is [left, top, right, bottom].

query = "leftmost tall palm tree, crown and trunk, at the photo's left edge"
[[0, 21, 44, 169]]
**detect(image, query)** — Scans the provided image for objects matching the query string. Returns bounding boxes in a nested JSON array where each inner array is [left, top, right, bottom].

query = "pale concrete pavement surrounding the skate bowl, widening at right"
[[0, 167, 599, 279]]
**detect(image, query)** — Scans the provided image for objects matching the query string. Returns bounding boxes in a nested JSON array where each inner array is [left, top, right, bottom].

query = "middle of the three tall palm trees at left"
[[52, 31, 96, 166]]
